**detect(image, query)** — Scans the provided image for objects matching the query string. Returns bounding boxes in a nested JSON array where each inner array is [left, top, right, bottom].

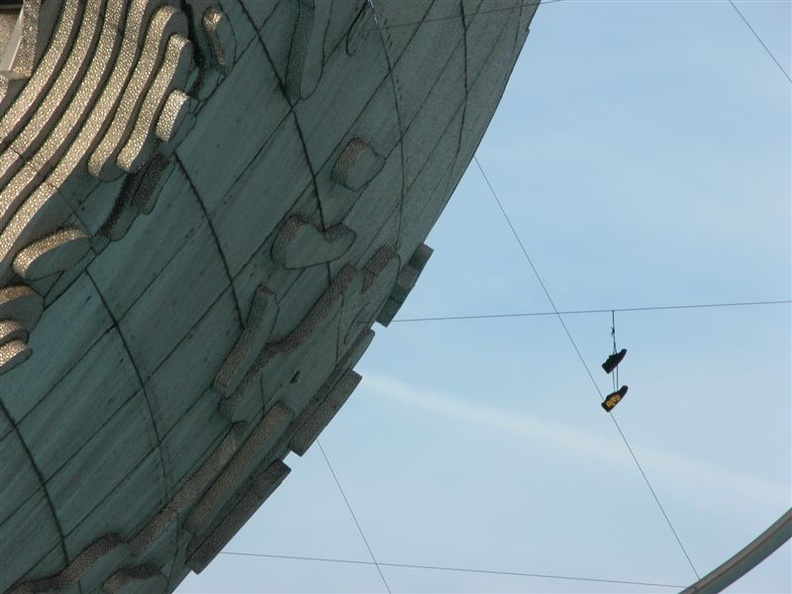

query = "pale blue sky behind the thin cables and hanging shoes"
[[178, 0, 792, 594]]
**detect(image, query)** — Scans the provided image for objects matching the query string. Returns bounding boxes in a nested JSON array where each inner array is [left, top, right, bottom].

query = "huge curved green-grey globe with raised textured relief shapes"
[[0, 0, 536, 594]]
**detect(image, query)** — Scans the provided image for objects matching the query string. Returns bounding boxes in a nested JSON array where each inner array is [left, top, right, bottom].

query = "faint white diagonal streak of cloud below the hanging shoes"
[[364, 373, 790, 513]]
